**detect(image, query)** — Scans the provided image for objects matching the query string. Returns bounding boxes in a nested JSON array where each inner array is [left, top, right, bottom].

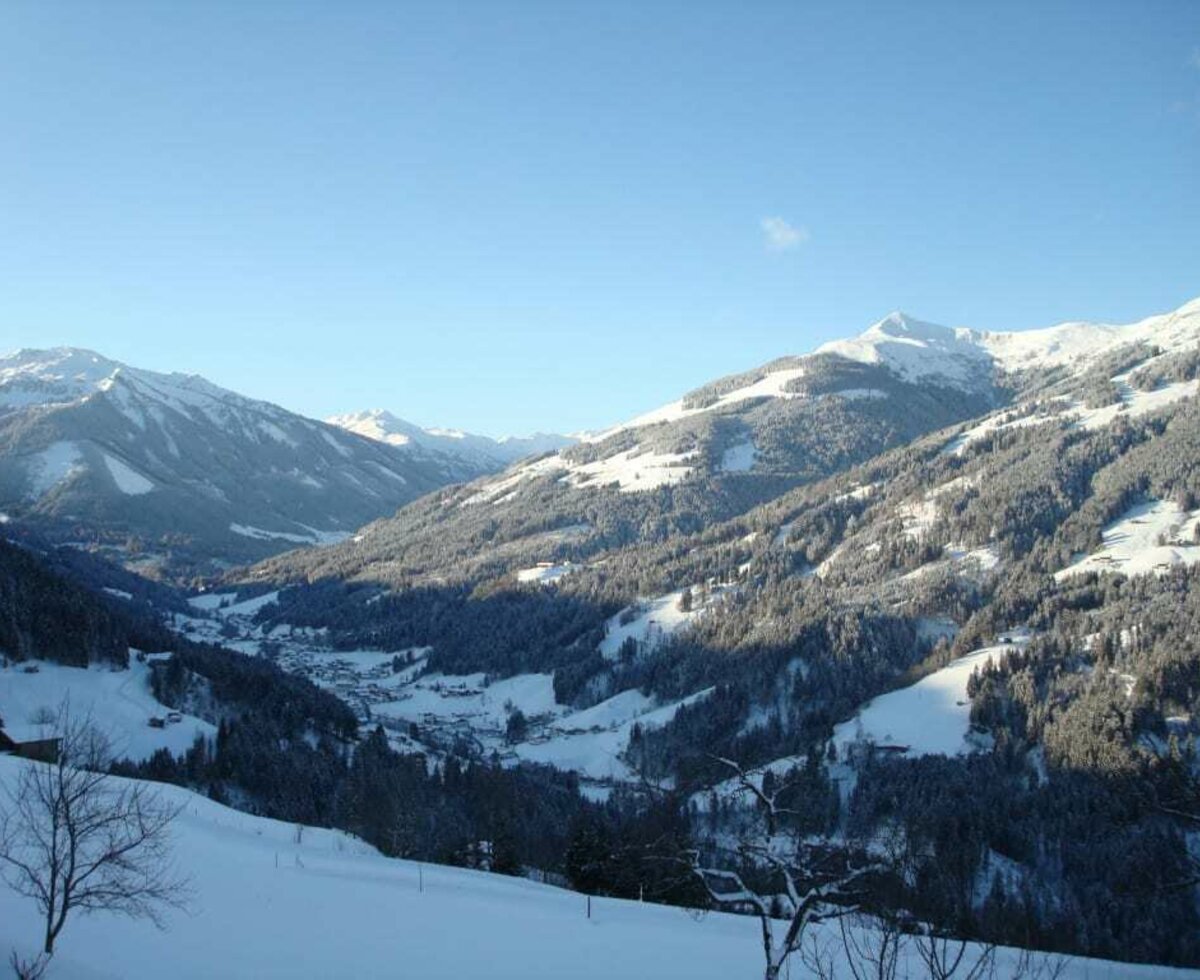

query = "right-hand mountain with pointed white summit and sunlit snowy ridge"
[[264, 290, 1200, 592]]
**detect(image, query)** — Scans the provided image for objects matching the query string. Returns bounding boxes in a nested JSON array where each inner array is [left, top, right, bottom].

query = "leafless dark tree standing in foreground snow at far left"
[[0, 705, 187, 956]]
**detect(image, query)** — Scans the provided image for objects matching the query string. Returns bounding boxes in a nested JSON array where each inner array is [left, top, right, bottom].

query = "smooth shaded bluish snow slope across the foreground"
[[0, 757, 1180, 980]]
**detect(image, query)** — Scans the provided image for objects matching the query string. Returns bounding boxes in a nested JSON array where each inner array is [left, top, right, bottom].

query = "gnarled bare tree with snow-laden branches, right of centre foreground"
[[685, 759, 883, 980]]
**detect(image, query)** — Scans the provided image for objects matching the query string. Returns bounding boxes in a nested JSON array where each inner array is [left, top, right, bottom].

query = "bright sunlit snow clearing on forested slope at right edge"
[[1055, 500, 1200, 582]]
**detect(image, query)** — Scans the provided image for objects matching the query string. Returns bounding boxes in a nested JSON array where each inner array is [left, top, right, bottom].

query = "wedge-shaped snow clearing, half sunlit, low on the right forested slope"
[[833, 637, 1024, 759]]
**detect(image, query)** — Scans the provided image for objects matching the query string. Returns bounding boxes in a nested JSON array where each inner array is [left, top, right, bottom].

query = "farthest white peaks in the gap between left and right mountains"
[[325, 408, 578, 479]]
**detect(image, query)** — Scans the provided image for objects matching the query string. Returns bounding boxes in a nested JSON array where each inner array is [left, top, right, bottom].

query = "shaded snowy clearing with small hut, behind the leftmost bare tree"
[[0, 656, 216, 759]]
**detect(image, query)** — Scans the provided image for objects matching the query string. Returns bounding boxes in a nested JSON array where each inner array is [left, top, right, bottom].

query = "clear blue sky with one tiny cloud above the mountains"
[[0, 0, 1200, 434]]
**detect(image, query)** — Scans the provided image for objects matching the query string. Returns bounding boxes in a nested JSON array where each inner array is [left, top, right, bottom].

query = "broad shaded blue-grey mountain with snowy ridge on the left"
[[0, 348, 487, 570]]
